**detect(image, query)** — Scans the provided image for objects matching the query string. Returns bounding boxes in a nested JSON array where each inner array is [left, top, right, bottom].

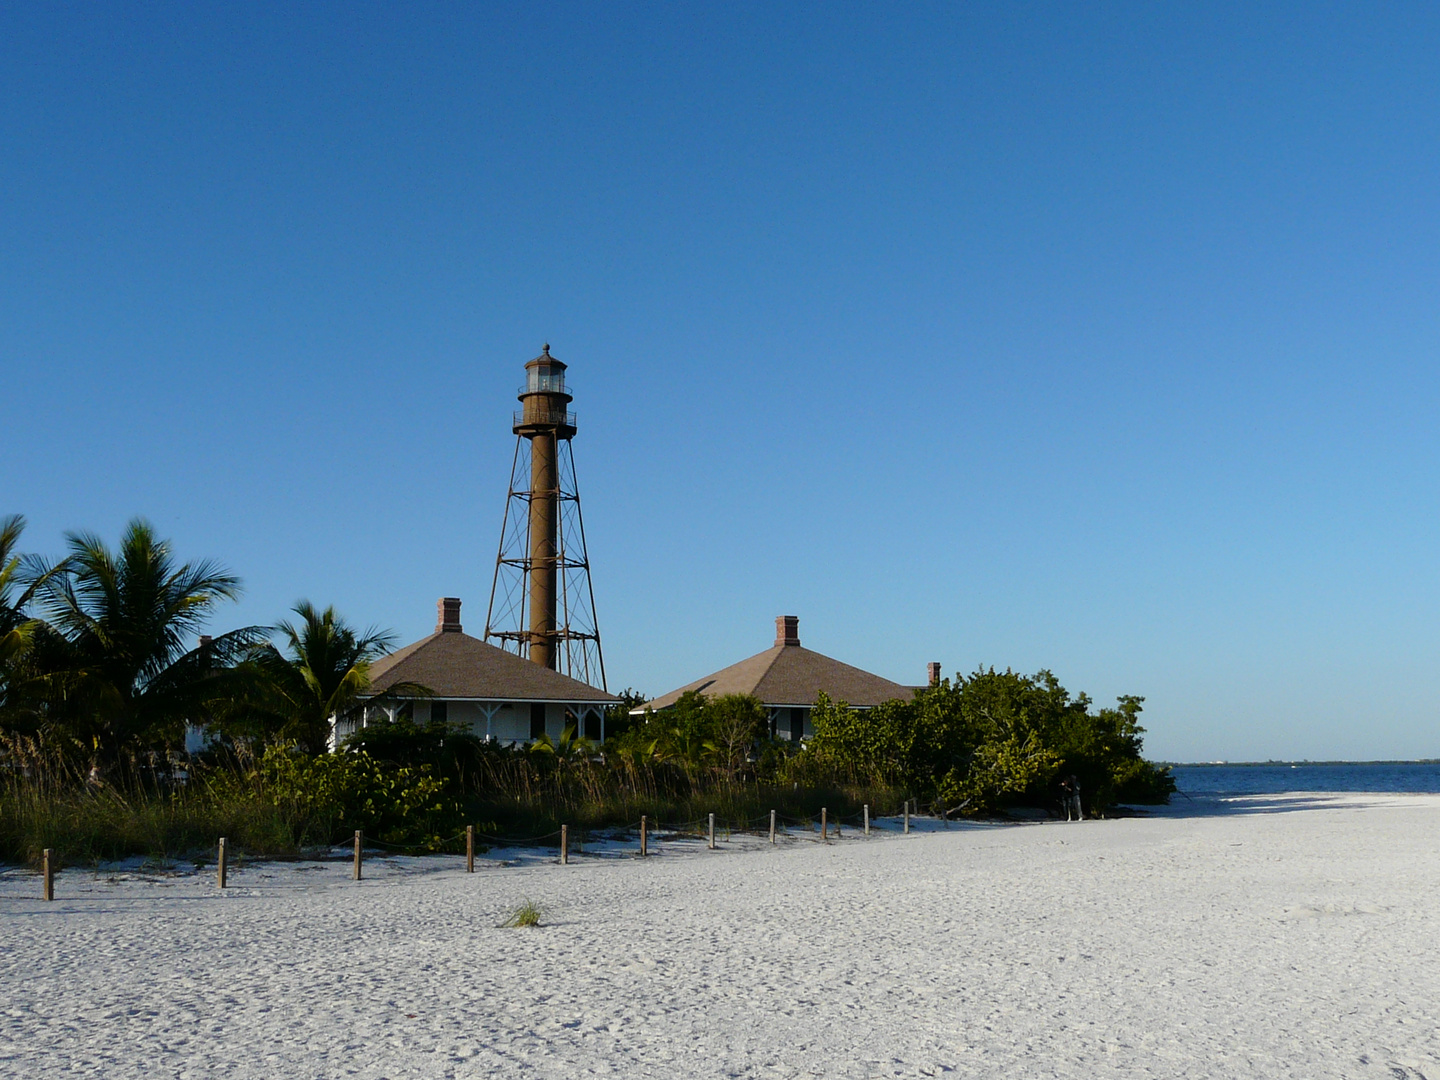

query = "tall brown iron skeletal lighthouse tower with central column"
[[485, 344, 606, 690]]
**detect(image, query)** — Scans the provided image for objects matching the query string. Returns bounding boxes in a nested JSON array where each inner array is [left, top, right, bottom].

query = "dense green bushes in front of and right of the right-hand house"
[[605, 668, 1175, 815]]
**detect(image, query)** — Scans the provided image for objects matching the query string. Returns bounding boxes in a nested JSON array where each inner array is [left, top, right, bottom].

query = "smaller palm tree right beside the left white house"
[[255, 600, 403, 753]]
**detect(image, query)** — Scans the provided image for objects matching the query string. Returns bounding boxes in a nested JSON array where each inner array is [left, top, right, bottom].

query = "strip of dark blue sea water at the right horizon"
[[1171, 762, 1440, 795]]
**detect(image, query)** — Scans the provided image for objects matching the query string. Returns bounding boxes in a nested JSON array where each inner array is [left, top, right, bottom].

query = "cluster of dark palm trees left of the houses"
[[0, 516, 400, 765]]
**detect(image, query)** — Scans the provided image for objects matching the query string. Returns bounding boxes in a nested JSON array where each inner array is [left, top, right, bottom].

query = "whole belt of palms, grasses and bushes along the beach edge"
[[0, 516, 1174, 863]]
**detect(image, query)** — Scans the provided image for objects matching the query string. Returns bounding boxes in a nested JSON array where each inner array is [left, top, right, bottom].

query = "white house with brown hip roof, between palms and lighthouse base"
[[331, 596, 619, 744]]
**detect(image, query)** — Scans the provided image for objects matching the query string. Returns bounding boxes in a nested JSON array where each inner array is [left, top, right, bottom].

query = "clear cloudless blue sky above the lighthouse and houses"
[[0, 3, 1440, 759]]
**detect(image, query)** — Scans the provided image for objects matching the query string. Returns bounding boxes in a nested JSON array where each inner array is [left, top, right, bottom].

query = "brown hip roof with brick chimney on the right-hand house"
[[642, 615, 914, 713]]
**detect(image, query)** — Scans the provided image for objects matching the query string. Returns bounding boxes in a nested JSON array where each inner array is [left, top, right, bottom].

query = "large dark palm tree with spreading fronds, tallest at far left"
[[36, 518, 262, 760]]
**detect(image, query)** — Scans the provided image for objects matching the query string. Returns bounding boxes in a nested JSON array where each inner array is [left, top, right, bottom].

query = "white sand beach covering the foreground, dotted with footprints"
[[0, 795, 1440, 1080]]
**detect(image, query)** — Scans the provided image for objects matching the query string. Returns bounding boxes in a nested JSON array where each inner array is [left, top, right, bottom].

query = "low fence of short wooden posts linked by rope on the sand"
[[25, 801, 933, 900]]
